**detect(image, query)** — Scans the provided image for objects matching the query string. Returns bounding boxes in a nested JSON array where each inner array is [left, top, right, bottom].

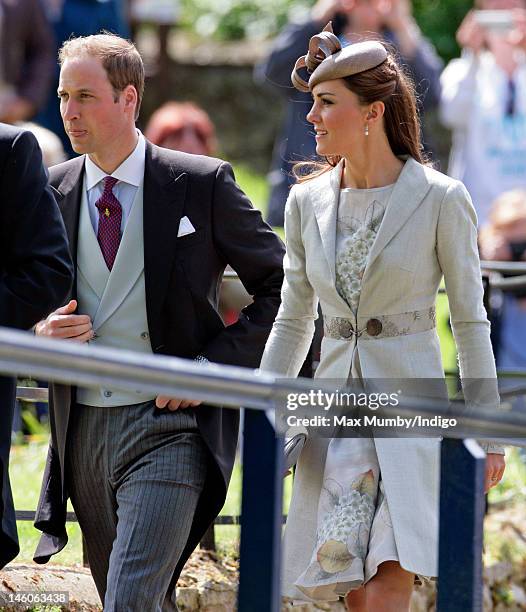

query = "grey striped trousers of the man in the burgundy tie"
[[65, 402, 208, 612]]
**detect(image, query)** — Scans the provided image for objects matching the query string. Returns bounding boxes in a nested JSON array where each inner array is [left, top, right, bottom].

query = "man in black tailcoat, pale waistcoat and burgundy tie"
[[35, 35, 283, 612]]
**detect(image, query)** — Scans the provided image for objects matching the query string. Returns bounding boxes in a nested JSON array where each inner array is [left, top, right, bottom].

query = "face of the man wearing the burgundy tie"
[[58, 54, 133, 157]]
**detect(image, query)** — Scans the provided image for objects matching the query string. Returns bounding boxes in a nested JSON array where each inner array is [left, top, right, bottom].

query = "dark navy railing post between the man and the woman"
[[238, 410, 283, 612]]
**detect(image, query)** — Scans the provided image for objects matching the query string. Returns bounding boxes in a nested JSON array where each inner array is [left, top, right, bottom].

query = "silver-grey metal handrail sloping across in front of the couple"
[[0, 328, 526, 439]]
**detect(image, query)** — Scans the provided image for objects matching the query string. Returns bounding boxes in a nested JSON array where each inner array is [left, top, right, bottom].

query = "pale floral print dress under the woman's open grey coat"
[[295, 185, 404, 600]]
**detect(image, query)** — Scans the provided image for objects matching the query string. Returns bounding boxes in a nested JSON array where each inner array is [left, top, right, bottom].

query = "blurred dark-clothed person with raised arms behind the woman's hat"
[[255, 0, 443, 226]]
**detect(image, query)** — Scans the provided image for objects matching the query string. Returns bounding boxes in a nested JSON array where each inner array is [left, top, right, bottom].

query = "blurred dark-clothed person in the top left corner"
[[0, 0, 55, 123]]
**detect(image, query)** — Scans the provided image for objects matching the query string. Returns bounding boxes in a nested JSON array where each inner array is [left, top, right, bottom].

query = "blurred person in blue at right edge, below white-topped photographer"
[[479, 189, 526, 370]]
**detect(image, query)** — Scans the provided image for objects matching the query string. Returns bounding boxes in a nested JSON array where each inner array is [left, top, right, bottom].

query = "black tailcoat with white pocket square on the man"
[[35, 142, 284, 579]]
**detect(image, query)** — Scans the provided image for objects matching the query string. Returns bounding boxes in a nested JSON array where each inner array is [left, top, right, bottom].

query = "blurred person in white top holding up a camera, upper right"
[[440, 0, 526, 226]]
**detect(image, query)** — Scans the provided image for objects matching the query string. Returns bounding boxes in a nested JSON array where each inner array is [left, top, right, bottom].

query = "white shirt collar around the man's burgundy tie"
[[84, 130, 146, 234]]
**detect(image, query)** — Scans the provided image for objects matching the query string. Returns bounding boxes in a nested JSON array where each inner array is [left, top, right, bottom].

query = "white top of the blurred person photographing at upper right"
[[440, 51, 526, 226]]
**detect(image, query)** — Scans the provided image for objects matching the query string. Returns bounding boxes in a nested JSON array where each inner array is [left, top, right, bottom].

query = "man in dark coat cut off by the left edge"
[[0, 123, 73, 569]]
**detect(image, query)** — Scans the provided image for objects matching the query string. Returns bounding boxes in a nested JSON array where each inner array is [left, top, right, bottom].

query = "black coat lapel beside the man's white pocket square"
[[143, 142, 187, 351]]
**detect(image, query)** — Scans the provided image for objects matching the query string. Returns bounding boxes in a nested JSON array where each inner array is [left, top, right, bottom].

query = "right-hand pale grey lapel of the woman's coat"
[[362, 157, 429, 283]]
